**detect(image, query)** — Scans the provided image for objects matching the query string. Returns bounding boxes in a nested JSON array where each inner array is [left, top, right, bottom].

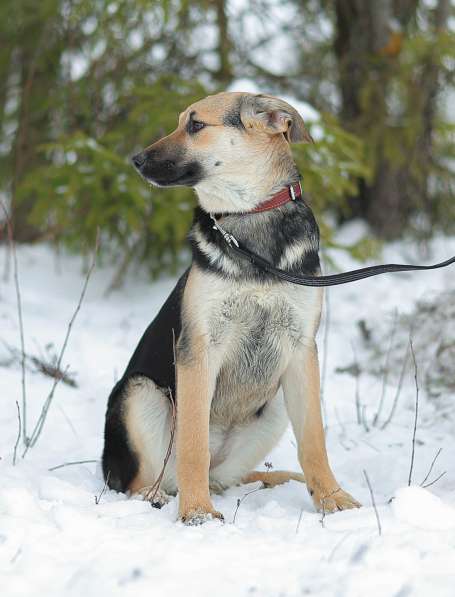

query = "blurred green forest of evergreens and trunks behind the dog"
[[0, 0, 455, 280]]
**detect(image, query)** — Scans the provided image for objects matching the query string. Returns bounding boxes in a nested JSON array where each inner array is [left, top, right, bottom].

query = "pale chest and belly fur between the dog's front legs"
[[189, 271, 322, 421]]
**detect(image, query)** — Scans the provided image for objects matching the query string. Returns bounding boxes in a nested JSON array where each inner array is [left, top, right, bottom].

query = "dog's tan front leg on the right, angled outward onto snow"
[[282, 338, 360, 512]]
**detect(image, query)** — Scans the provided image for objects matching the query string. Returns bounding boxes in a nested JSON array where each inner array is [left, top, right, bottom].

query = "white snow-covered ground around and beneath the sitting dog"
[[0, 228, 455, 597]]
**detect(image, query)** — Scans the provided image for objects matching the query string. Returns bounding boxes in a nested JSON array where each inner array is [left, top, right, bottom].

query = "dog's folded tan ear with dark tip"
[[240, 94, 314, 143]]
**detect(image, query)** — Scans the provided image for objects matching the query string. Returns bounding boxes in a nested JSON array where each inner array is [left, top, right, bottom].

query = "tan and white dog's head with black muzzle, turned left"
[[132, 93, 311, 211]]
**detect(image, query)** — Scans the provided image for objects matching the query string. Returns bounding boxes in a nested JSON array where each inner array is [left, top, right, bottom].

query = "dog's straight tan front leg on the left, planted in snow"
[[177, 339, 223, 524]]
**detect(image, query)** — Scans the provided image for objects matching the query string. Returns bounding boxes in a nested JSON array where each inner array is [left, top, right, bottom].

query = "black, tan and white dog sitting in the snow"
[[103, 92, 360, 524]]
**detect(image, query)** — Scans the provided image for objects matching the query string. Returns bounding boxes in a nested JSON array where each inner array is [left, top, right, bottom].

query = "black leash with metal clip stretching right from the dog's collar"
[[210, 216, 455, 287]]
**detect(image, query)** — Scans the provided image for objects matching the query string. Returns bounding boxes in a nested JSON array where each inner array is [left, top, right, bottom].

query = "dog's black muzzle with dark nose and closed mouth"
[[132, 154, 203, 187]]
